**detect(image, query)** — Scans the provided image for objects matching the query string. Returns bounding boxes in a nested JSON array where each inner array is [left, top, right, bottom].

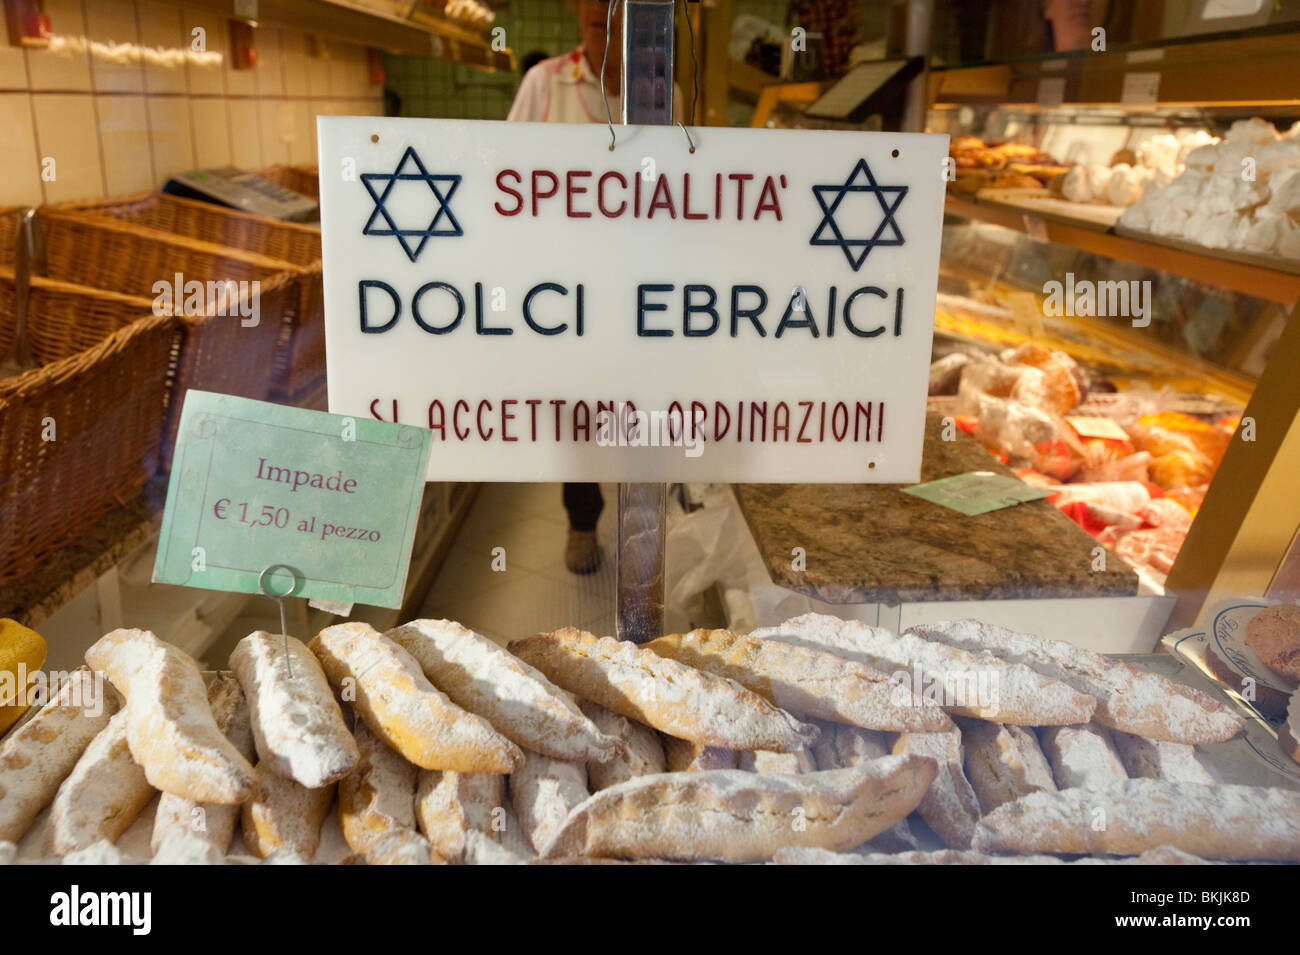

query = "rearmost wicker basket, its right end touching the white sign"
[[52, 192, 325, 398]]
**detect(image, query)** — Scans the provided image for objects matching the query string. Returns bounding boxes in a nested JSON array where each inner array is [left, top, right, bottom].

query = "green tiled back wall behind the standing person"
[[384, 0, 581, 120]]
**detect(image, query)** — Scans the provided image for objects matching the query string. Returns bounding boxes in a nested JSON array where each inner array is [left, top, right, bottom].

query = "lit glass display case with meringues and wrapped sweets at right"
[[928, 26, 1300, 613]]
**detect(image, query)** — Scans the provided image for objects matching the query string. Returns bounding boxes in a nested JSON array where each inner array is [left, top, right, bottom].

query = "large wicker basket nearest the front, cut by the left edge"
[[0, 270, 181, 587]]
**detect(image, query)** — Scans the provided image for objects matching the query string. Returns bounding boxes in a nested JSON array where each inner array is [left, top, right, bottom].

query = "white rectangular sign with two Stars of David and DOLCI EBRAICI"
[[319, 117, 948, 482]]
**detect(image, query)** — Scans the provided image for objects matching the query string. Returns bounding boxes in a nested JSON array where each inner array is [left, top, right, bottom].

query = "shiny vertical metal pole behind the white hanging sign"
[[611, 0, 676, 643]]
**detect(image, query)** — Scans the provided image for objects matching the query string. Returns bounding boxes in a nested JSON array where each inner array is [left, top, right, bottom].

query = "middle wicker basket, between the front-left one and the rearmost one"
[[40, 209, 302, 465]]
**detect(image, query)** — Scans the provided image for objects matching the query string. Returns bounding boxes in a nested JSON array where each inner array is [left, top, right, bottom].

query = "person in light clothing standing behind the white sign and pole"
[[506, 0, 681, 574]]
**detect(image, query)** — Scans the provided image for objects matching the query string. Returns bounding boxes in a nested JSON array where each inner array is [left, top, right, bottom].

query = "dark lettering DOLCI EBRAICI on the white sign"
[[356, 279, 904, 342]]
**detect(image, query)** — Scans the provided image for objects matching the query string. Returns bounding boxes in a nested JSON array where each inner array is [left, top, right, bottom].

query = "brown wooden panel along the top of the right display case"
[[930, 32, 1300, 109]]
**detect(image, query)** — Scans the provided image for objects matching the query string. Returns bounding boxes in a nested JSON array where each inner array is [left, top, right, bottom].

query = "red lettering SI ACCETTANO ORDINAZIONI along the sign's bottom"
[[371, 398, 885, 447]]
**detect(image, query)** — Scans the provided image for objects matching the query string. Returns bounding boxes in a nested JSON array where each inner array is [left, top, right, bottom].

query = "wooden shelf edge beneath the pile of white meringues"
[[944, 196, 1300, 309]]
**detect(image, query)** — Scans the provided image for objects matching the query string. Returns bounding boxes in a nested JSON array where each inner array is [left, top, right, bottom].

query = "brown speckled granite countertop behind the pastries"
[[733, 414, 1138, 604]]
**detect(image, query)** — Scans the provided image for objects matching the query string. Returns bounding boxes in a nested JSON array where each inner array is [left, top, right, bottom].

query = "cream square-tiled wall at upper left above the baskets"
[[0, 0, 384, 205]]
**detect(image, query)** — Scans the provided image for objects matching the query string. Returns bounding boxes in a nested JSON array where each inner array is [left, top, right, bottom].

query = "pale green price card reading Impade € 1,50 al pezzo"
[[153, 391, 429, 607]]
